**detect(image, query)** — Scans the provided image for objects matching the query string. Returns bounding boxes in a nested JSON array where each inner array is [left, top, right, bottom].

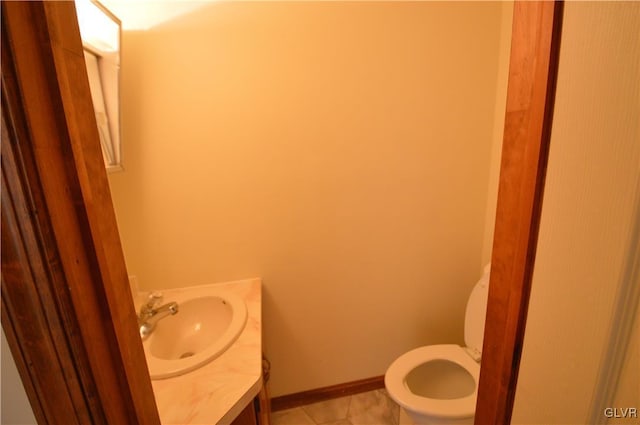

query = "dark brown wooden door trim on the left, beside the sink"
[[2, 1, 160, 424]]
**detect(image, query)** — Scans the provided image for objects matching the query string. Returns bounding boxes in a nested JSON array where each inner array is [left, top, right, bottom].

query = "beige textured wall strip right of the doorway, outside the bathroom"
[[513, 2, 640, 424]]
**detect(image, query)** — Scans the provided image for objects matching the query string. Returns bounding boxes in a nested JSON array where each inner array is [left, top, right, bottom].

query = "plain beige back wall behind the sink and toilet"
[[110, 2, 510, 396]]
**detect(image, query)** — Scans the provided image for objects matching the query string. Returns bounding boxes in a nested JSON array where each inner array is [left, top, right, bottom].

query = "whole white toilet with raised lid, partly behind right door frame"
[[384, 265, 491, 425]]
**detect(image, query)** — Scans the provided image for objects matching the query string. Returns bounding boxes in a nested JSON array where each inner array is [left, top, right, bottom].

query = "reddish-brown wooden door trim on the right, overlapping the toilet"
[[475, 1, 562, 425]]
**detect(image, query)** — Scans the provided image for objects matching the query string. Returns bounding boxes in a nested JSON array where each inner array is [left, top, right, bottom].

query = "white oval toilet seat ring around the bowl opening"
[[384, 344, 480, 418]]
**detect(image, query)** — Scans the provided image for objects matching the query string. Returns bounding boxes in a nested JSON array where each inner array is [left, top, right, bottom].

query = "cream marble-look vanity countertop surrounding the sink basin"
[[144, 279, 262, 425]]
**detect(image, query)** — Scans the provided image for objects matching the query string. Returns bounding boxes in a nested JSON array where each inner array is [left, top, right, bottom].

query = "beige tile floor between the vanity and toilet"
[[271, 389, 411, 425]]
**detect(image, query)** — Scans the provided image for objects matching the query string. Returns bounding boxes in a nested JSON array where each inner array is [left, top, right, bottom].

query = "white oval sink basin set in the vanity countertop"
[[143, 291, 247, 379]]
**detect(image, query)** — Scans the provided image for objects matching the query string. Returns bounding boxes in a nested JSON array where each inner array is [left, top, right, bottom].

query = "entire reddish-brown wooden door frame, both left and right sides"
[[2, 1, 561, 424]]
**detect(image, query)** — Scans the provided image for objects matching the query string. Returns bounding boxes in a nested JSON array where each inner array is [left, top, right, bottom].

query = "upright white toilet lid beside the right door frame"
[[464, 264, 491, 360]]
